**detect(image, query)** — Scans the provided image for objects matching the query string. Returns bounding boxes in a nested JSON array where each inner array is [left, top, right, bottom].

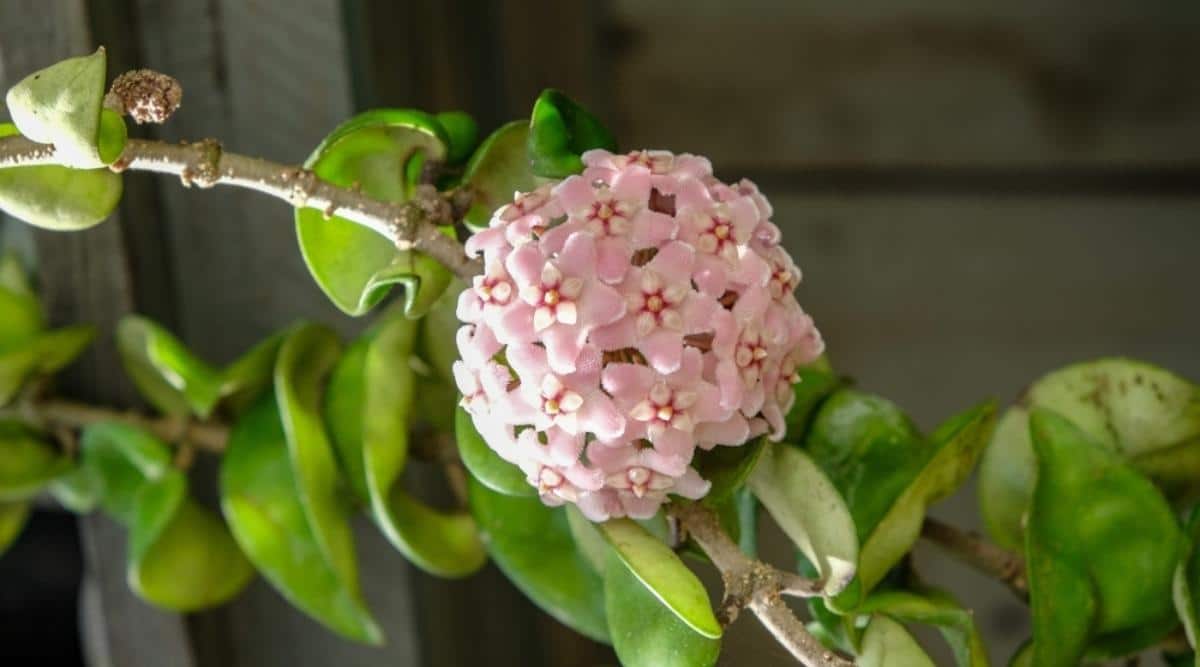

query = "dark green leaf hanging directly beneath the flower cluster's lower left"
[[469, 477, 608, 642]]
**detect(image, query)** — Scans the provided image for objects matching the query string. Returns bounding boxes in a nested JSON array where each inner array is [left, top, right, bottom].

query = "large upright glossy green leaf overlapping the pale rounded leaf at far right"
[[1026, 408, 1182, 667]]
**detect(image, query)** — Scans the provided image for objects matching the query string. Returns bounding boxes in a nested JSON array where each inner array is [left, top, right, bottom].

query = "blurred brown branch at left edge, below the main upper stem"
[[0, 398, 229, 452]]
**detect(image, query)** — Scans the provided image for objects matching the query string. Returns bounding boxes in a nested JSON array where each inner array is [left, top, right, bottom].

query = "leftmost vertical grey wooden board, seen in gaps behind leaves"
[[0, 0, 193, 667]]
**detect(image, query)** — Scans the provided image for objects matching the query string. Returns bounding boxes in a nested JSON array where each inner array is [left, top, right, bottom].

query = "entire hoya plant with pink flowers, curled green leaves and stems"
[[0, 49, 1200, 667]]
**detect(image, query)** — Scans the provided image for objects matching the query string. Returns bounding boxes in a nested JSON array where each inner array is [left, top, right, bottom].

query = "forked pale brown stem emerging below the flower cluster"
[[672, 504, 853, 667]]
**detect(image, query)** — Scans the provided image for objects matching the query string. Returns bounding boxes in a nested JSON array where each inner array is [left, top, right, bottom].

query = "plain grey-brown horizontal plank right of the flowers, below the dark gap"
[[772, 194, 1200, 425]]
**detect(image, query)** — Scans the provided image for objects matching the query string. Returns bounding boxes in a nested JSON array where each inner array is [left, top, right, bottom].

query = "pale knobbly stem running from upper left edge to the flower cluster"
[[0, 136, 482, 278]]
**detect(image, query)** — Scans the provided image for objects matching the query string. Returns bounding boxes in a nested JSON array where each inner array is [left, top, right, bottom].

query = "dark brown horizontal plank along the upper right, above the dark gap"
[[605, 0, 1200, 167]]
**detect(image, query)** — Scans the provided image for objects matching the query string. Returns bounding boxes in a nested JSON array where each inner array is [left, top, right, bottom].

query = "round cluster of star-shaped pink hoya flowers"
[[455, 151, 823, 521]]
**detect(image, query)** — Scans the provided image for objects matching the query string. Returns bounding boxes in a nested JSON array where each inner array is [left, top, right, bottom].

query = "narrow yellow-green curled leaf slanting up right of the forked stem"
[[859, 402, 996, 590]]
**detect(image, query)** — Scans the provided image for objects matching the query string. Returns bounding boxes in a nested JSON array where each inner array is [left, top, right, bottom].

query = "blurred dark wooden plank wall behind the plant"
[[0, 0, 1200, 667]]
